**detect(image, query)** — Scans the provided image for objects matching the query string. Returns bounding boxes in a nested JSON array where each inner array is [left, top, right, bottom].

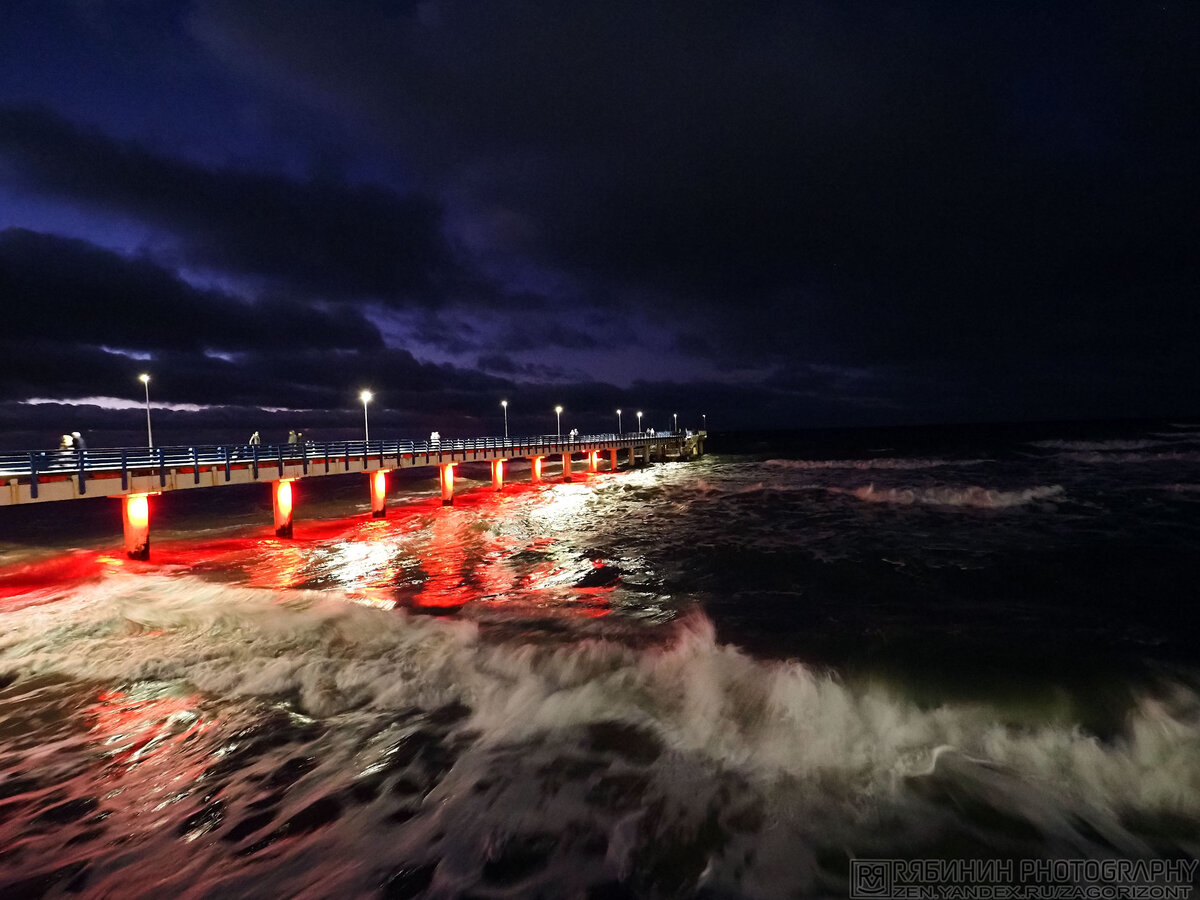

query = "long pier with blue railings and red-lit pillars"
[[0, 431, 707, 559]]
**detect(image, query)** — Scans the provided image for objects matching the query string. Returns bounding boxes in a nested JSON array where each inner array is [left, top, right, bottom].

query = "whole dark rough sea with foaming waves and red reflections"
[[0, 421, 1200, 900]]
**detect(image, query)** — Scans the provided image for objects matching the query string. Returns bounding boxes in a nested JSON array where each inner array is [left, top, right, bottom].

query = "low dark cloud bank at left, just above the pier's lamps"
[[0, 228, 504, 417]]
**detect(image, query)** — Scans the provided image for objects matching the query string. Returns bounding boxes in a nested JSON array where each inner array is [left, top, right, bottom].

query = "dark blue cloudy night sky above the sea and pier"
[[0, 0, 1200, 448]]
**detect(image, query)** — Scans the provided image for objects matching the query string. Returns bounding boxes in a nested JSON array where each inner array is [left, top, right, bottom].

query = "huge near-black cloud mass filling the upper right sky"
[[197, 1, 1200, 367]]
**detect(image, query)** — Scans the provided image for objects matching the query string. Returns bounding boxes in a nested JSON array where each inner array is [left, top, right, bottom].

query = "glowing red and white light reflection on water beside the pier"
[[0, 463, 633, 617]]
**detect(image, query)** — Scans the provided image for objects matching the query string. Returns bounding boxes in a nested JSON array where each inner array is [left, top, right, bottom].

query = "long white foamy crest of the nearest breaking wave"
[[0, 576, 1200, 815]]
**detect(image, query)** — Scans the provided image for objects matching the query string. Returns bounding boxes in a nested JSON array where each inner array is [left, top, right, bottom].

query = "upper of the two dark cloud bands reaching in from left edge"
[[0, 108, 470, 305]]
